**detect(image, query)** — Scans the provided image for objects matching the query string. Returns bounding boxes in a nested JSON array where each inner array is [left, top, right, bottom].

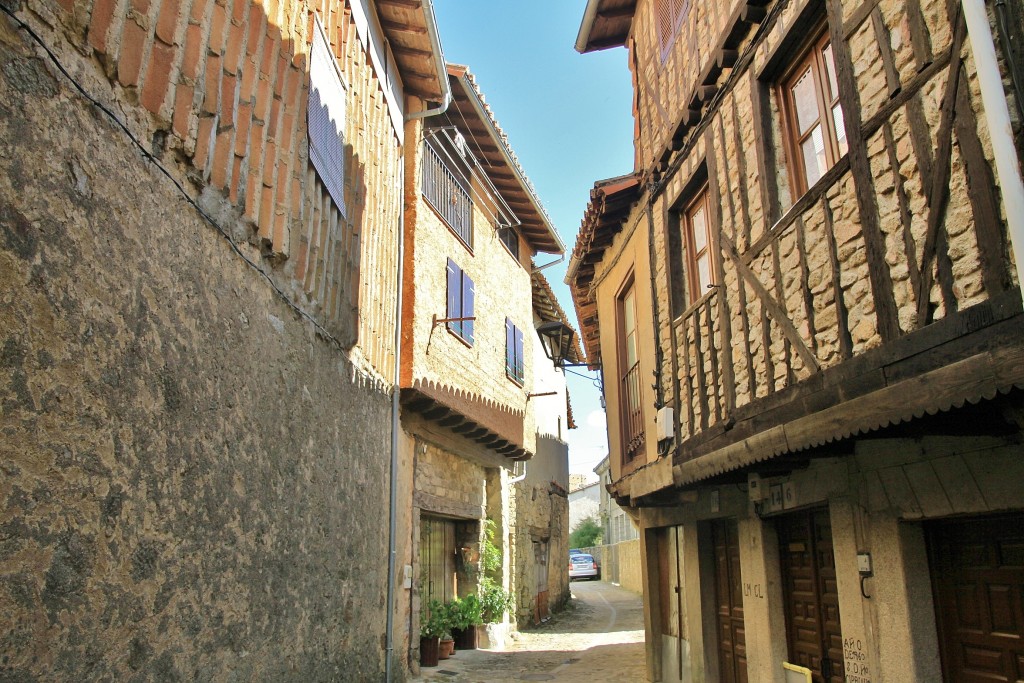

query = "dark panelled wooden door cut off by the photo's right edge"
[[928, 514, 1024, 683]]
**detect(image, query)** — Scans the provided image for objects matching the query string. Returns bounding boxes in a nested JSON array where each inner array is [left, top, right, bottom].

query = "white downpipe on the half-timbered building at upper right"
[[962, 0, 1024, 289]]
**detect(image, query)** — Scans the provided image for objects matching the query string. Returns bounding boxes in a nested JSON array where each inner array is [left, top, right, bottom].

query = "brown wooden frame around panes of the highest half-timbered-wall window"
[[775, 23, 846, 197]]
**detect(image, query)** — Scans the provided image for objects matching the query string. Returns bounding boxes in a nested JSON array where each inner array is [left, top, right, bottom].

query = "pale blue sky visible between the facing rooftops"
[[434, 0, 633, 472]]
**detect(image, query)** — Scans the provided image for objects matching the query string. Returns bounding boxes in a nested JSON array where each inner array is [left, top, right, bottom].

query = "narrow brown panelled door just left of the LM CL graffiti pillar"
[[711, 519, 746, 683]]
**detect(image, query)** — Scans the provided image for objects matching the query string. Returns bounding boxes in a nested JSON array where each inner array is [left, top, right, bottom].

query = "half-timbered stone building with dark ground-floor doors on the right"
[[567, 0, 1024, 683]]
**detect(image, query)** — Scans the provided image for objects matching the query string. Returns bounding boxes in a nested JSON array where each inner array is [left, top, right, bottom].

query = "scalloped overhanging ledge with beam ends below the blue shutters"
[[399, 380, 534, 462]]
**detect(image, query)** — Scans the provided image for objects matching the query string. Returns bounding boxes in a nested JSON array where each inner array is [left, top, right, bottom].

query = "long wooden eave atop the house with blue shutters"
[[447, 65, 565, 254]]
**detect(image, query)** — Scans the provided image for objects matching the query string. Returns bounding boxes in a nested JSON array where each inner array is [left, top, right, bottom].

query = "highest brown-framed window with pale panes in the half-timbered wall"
[[779, 29, 848, 197]]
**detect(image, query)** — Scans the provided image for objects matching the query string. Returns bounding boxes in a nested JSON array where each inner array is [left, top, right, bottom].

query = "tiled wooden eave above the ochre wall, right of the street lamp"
[[568, 173, 641, 362]]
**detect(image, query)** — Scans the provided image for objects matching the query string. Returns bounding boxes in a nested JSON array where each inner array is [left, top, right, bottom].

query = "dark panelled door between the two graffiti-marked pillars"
[[778, 509, 845, 683]]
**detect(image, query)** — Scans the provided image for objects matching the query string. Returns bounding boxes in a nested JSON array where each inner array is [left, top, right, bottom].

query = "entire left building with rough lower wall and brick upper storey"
[[0, 0, 446, 681]]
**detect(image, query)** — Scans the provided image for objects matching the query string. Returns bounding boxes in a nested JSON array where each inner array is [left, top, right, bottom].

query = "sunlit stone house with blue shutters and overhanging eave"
[[399, 65, 567, 667]]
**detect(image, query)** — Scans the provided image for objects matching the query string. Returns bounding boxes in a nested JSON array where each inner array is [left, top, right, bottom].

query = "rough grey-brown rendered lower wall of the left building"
[[0, 17, 389, 681]]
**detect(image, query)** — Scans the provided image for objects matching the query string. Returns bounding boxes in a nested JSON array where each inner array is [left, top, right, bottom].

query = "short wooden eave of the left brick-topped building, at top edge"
[[376, 0, 446, 101]]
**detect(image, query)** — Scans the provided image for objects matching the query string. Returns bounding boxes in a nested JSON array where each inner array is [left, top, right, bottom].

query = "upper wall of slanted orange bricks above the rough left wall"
[[23, 0, 401, 377]]
